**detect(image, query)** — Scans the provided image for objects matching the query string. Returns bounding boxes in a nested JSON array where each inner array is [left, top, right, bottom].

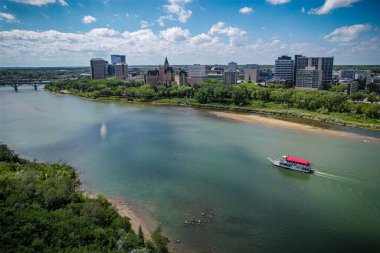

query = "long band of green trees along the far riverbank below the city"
[[45, 79, 380, 119]]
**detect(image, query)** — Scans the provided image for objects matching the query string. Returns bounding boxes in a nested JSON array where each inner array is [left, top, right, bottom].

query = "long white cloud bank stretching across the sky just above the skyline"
[[0, 22, 380, 66]]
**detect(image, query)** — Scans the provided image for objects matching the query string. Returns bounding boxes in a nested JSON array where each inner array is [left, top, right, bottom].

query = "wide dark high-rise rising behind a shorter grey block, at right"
[[294, 55, 334, 85]]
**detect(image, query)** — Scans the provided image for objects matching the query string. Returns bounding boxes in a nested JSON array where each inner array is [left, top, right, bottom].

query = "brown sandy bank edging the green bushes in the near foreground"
[[83, 191, 156, 239]]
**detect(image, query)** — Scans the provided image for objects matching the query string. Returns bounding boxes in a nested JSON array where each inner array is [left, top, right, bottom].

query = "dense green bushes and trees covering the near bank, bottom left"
[[0, 144, 166, 252]]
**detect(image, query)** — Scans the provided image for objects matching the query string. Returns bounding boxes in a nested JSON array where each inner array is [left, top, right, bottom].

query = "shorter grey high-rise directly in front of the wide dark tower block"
[[296, 66, 323, 89]]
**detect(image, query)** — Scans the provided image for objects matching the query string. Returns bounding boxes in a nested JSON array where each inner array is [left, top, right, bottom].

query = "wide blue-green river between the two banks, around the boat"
[[0, 88, 380, 252]]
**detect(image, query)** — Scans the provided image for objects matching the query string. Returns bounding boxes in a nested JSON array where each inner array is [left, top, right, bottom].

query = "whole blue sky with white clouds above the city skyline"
[[0, 0, 380, 67]]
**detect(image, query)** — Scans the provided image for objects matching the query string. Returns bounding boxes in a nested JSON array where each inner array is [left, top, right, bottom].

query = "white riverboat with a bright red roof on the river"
[[268, 155, 313, 173]]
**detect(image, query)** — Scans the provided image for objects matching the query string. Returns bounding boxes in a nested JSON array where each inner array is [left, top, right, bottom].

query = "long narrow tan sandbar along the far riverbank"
[[209, 111, 378, 140]]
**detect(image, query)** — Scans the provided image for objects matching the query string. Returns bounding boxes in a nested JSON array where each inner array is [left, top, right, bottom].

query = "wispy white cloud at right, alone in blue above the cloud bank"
[[323, 24, 372, 43]]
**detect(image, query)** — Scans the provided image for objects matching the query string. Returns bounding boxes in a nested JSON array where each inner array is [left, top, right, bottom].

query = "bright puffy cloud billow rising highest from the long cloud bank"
[[208, 22, 247, 46]]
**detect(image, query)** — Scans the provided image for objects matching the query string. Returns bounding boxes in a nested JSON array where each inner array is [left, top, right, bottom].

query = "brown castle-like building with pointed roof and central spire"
[[144, 58, 174, 85]]
